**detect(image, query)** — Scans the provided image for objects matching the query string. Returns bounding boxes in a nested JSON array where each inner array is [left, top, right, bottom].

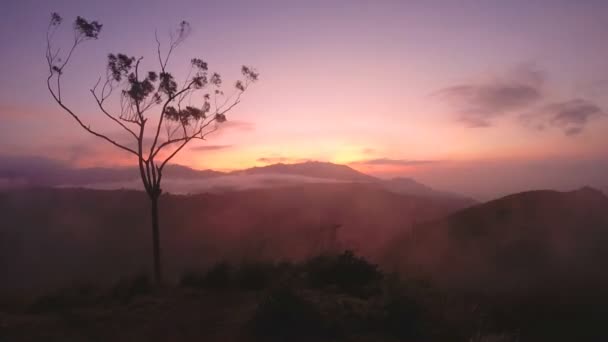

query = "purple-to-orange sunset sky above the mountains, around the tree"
[[0, 0, 608, 198]]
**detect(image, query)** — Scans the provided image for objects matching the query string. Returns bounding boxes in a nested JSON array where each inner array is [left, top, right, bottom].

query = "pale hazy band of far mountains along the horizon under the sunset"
[[0, 158, 474, 205]]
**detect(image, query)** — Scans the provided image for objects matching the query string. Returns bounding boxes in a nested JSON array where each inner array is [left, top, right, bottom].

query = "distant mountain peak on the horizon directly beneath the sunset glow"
[[232, 161, 378, 182]]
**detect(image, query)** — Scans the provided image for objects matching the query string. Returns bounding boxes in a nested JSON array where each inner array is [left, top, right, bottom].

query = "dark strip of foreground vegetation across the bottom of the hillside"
[[0, 251, 607, 342]]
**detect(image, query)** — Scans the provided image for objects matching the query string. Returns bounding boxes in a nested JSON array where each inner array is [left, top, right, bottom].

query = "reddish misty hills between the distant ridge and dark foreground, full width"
[[0, 183, 608, 291]]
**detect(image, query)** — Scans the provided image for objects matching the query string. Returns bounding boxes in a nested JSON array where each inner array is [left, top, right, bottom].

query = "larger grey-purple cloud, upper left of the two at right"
[[435, 66, 545, 127]]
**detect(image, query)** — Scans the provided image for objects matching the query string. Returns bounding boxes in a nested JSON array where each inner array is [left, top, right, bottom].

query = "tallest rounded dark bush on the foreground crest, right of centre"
[[305, 251, 383, 298]]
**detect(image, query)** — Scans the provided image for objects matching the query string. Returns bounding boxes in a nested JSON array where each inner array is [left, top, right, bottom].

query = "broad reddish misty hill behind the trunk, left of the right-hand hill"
[[0, 183, 470, 289]]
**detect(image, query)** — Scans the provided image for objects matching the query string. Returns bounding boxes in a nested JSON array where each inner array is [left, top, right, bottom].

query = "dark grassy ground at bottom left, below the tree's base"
[[0, 290, 256, 341]]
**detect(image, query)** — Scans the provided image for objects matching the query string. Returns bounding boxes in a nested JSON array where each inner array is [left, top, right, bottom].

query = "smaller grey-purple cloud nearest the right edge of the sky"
[[520, 98, 606, 136]]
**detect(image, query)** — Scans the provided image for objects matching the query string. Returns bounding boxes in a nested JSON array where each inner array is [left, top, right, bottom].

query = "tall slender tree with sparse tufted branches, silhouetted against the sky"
[[46, 13, 258, 283]]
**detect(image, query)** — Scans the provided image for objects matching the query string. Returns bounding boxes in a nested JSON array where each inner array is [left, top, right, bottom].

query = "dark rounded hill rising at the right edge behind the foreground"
[[387, 188, 608, 291]]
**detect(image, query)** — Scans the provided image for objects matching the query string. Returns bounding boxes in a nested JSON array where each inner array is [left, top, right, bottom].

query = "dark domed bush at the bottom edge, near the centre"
[[250, 288, 330, 341]]
